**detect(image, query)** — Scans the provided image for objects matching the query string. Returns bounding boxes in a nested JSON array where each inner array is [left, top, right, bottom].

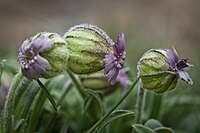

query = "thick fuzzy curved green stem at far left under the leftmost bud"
[[2, 72, 23, 133]]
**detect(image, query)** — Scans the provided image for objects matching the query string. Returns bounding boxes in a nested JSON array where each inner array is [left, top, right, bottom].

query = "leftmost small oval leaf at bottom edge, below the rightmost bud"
[[132, 124, 156, 133]]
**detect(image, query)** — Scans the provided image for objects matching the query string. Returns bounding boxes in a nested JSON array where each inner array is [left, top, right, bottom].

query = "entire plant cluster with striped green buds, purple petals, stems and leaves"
[[0, 24, 192, 133]]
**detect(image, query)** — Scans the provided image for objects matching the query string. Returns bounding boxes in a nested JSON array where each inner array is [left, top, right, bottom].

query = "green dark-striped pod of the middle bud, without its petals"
[[64, 24, 114, 74]]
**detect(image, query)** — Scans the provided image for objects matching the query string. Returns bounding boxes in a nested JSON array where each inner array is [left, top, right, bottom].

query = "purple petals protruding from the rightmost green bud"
[[166, 47, 193, 85]]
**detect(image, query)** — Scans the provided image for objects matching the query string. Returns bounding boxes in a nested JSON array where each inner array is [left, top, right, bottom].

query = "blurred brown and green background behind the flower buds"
[[0, 0, 200, 132]]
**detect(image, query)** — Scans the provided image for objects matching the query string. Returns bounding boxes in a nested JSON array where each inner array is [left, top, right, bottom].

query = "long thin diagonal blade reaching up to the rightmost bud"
[[87, 77, 140, 133]]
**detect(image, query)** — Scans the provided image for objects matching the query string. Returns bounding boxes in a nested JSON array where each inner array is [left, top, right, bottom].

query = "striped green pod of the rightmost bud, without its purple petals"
[[137, 49, 178, 93]]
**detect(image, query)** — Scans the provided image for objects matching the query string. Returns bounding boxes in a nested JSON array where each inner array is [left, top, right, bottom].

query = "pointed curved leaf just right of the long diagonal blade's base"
[[98, 110, 134, 132]]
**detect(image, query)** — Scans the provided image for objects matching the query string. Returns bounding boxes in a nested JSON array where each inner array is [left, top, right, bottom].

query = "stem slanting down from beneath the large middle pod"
[[67, 69, 86, 98]]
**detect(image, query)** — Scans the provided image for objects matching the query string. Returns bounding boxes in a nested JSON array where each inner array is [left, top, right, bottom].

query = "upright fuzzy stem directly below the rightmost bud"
[[135, 85, 145, 123]]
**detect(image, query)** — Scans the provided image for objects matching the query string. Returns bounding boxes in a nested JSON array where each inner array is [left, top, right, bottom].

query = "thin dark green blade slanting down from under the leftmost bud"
[[37, 79, 58, 112]]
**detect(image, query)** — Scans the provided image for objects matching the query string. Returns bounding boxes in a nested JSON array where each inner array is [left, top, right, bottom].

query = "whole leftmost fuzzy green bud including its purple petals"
[[18, 32, 69, 80]]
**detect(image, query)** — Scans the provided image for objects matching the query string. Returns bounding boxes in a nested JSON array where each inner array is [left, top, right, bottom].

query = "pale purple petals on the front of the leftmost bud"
[[18, 34, 54, 80]]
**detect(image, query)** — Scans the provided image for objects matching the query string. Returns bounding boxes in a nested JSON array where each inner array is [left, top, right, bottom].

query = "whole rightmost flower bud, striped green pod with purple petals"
[[137, 48, 192, 93]]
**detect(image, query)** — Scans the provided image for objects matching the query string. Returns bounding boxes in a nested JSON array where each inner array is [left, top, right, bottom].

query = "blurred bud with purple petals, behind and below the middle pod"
[[80, 69, 128, 94]]
